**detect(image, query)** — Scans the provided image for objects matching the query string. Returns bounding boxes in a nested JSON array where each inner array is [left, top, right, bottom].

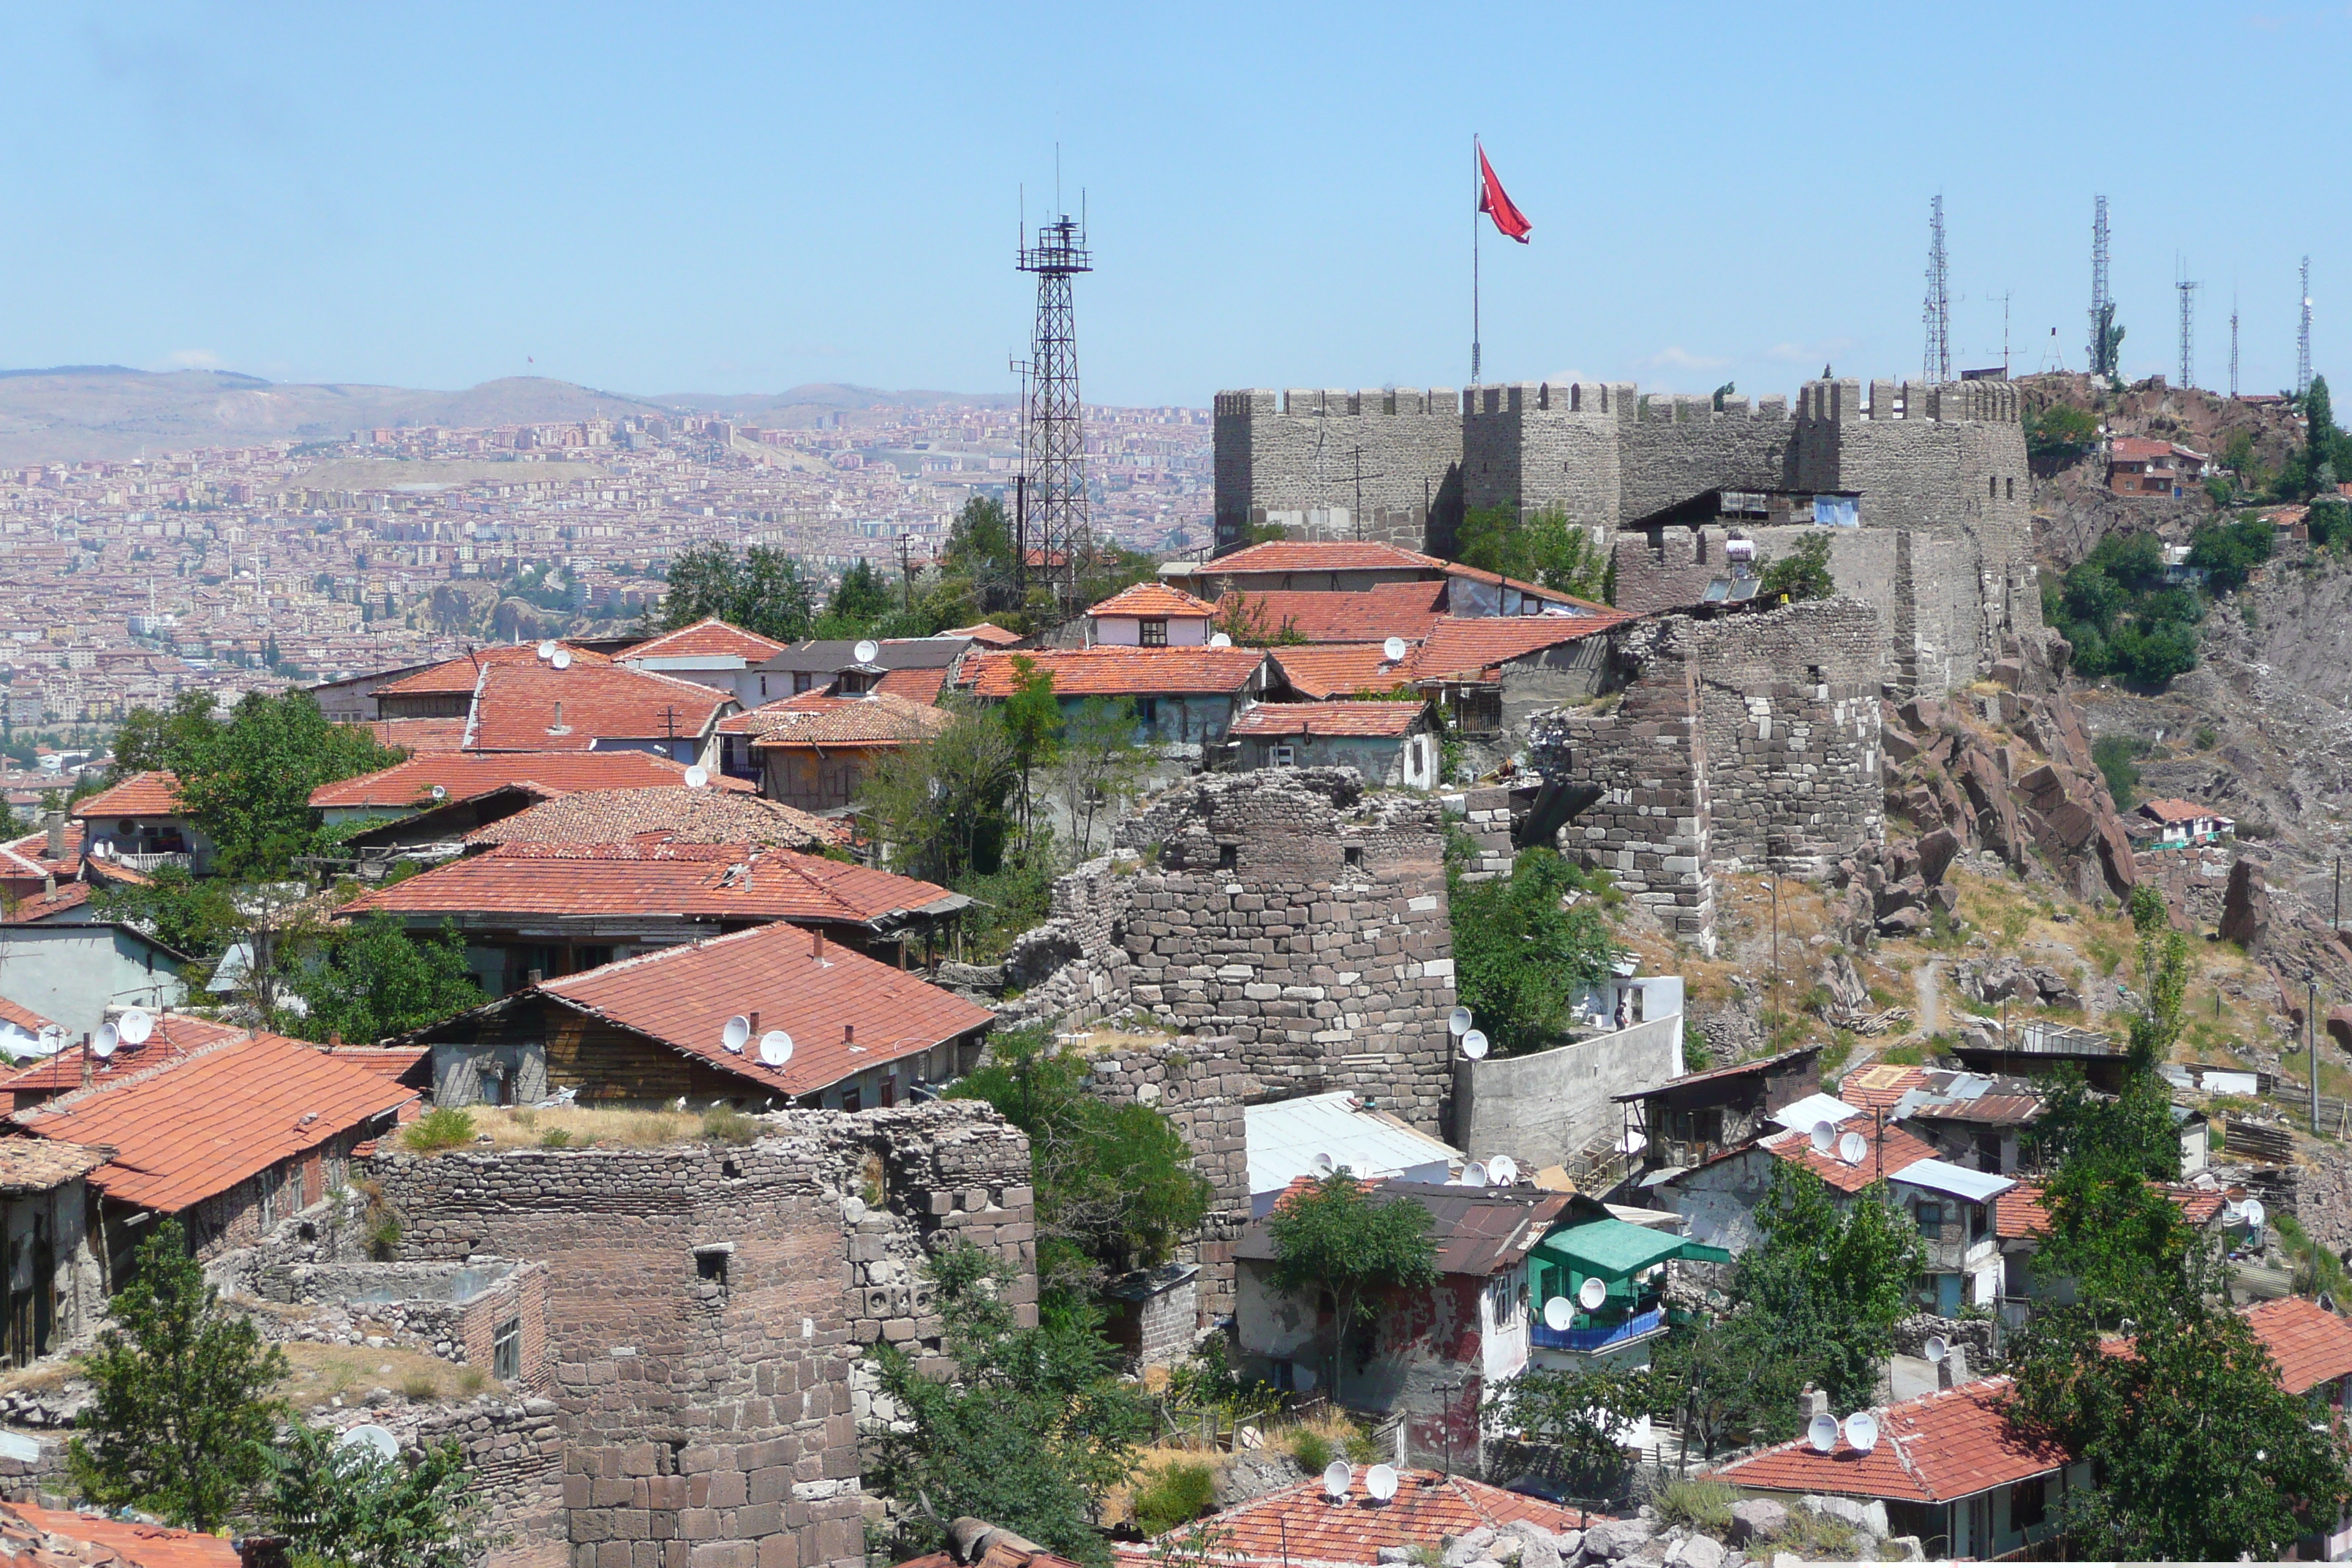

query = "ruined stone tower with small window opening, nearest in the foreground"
[[374, 1103, 1037, 1568]]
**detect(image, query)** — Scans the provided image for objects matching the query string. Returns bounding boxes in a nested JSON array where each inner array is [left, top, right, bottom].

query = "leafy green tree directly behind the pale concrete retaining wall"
[[1447, 846, 1618, 1055]]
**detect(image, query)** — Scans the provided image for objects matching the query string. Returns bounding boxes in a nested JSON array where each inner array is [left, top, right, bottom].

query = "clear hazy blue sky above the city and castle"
[[0, 0, 2352, 404]]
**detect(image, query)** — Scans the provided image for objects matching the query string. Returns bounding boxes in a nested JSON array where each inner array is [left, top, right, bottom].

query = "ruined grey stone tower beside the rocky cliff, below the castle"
[[1529, 600, 1886, 943]]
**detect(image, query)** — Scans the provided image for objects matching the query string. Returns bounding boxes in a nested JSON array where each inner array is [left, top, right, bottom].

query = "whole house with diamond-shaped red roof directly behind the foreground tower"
[[402, 926, 995, 1109]]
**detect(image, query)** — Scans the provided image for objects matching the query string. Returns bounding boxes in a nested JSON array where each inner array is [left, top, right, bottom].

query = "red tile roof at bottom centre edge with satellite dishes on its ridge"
[[1117, 1465, 1604, 1566]]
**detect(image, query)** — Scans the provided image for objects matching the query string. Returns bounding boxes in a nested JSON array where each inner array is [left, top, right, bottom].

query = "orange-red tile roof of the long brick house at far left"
[[12, 1034, 416, 1213]]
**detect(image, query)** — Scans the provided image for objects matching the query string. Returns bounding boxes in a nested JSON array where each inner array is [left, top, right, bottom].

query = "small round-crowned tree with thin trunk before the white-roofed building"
[[1267, 1171, 1437, 1399]]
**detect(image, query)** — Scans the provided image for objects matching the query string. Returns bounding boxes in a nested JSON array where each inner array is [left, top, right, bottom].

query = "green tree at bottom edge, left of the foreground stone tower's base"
[[261, 1422, 497, 1568]]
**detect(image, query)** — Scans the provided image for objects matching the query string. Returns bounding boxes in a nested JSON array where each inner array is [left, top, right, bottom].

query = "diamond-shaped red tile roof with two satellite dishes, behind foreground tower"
[[515, 926, 995, 1096]]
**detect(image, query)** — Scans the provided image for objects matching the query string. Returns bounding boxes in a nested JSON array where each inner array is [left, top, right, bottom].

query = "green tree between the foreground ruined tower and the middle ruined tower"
[[948, 1028, 1213, 1309]]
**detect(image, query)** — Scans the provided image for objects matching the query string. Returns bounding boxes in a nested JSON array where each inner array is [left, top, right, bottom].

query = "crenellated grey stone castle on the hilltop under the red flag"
[[1216, 381, 2041, 696]]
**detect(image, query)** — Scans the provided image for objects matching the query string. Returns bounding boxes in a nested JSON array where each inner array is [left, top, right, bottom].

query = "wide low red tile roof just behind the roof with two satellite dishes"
[[344, 844, 955, 924]]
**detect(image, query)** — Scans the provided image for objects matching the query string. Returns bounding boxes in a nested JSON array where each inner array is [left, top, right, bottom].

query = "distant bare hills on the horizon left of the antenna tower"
[[0, 364, 1011, 463]]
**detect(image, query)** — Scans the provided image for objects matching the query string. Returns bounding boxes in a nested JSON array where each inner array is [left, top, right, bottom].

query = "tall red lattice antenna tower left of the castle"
[[1016, 214, 1093, 606]]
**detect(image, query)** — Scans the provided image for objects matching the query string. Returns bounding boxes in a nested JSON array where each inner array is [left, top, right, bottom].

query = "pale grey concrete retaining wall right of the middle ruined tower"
[[1453, 1011, 1681, 1171]]
